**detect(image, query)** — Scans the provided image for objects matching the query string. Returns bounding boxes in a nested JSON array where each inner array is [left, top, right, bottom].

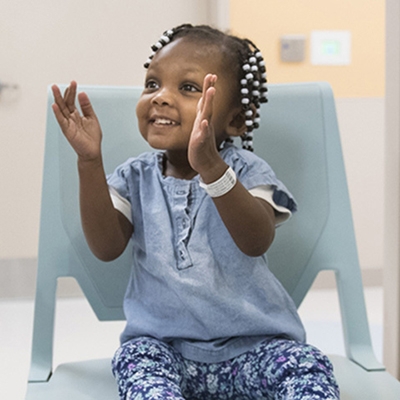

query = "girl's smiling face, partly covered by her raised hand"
[[136, 38, 241, 153]]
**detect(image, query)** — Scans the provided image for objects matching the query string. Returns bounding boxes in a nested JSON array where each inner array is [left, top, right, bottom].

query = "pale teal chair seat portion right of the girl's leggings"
[[329, 355, 400, 400]]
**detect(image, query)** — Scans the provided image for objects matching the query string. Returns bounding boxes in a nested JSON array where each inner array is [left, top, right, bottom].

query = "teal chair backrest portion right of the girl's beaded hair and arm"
[[255, 83, 359, 298]]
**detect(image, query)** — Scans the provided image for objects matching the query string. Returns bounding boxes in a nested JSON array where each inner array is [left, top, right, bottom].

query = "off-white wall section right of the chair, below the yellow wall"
[[336, 97, 385, 276]]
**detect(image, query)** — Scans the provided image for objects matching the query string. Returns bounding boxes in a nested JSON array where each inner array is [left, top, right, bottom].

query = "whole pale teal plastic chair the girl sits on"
[[26, 83, 400, 400]]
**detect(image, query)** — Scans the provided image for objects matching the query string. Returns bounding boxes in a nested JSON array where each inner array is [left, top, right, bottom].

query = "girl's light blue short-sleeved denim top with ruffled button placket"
[[107, 144, 305, 362]]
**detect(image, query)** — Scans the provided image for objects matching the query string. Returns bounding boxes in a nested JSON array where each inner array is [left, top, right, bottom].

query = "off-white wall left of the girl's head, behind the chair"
[[0, 0, 208, 259]]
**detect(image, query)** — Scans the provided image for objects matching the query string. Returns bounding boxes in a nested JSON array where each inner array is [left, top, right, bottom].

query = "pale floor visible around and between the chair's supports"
[[0, 287, 383, 400]]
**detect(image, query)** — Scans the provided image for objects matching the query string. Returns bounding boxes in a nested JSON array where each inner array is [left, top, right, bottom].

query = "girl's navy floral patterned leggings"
[[112, 337, 339, 400]]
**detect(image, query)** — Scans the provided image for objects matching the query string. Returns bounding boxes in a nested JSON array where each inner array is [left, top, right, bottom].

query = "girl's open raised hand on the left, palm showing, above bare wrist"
[[51, 81, 102, 161]]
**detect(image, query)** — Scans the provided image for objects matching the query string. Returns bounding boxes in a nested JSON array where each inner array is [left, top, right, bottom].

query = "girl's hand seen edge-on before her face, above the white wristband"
[[188, 74, 225, 178]]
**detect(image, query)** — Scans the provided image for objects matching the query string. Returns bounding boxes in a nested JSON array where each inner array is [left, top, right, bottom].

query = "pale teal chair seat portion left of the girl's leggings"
[[26, 359, 118, 400]]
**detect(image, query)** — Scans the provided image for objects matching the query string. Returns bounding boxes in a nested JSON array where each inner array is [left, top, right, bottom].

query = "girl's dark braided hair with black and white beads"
[[144, 24, 268, 151]]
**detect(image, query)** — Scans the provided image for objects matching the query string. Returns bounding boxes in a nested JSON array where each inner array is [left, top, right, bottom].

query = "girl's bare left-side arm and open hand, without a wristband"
[[52, 82, 133, 261]]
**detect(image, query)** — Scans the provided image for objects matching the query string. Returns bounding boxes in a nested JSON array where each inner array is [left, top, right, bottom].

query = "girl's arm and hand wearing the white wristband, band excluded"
[[188, 75, 275, 256]]
